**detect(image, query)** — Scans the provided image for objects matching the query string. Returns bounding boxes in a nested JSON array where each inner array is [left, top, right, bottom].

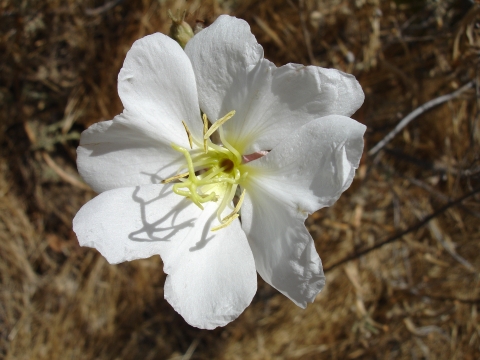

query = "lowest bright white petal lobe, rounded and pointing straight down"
[[165, 209, 257, 329]]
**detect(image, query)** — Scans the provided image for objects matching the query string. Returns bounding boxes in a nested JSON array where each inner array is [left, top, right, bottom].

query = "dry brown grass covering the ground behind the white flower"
[[0, 0, 480, 359]]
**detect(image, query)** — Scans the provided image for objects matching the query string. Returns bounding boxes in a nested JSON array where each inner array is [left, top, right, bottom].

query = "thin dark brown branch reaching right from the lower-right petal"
[[323, 187, 480, 272]]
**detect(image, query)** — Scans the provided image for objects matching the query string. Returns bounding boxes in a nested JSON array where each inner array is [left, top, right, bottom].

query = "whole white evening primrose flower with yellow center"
[[73, 16, 365, 329]]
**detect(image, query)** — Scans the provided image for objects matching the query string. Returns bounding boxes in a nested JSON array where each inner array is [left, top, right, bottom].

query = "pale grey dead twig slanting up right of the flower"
[[368, 80, 475, 156]]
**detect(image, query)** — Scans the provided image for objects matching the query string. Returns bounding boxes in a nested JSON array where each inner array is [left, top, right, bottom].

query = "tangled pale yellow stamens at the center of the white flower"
[[163, 110, 247, 231]]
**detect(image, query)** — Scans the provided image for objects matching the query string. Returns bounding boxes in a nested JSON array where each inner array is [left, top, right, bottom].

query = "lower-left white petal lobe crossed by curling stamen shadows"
[[73, 184, 186, 264]]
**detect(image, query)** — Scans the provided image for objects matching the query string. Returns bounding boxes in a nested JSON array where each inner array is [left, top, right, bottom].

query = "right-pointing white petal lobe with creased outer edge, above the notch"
[[246, 115, 366, 213]]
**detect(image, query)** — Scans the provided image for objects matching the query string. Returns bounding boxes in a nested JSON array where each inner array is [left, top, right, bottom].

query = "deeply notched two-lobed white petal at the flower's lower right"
[[242, 116, 365, 307]]
